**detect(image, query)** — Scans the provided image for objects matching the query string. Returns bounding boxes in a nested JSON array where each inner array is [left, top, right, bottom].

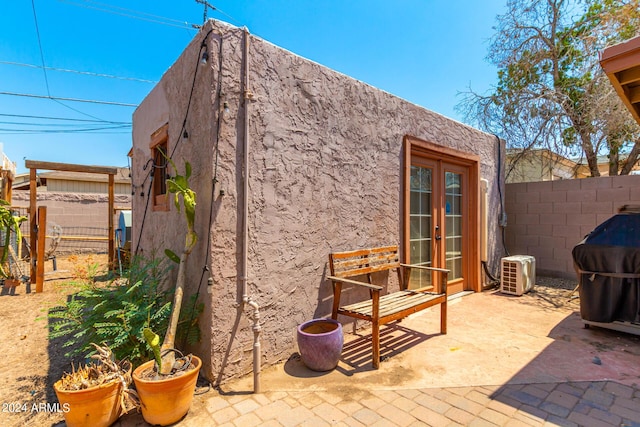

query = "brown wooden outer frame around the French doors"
[[400, 135, 482, 292]]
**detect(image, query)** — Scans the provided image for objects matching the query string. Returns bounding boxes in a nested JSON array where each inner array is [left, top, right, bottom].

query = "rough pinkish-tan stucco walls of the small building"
[[132, 21, 501, 381]]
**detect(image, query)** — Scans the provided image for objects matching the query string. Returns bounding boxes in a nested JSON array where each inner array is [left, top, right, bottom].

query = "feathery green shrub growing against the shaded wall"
[[49, 257, 203, 366]]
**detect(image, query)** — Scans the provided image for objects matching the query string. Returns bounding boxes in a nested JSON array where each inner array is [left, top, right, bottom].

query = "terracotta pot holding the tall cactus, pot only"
[[133, 356, 202, 426]]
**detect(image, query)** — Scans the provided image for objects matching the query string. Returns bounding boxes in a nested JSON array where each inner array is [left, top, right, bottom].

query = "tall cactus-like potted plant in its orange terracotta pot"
[[133, 159, 202, 426]]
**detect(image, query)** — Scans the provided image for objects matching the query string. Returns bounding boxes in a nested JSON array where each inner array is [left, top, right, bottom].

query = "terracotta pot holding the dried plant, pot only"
[[53, 378, 125, 427]]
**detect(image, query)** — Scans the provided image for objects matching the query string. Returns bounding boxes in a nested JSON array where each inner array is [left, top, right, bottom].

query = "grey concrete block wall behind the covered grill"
[[505, 175, 640, 278]]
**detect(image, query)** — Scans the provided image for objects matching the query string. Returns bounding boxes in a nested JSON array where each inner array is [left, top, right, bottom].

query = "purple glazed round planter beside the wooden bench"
[[298, 319, 344, 371]]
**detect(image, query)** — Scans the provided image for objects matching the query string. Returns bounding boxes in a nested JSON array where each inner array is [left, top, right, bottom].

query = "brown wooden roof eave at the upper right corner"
[[600, 36, 640, 124]]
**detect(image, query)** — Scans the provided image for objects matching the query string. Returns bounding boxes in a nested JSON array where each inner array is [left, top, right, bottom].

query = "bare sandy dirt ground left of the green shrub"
[[0, 255, 107, 426]]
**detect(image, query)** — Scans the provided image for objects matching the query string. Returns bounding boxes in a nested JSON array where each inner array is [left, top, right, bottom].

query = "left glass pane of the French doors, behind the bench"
[[409, 166, 433, 289]]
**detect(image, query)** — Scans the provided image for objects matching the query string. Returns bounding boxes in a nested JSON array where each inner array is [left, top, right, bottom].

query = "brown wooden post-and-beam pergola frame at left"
[[25, 160, 118, 292]]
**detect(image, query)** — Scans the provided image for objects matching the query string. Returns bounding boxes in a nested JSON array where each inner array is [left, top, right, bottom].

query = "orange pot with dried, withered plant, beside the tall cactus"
[[53, 344, 137, 427]]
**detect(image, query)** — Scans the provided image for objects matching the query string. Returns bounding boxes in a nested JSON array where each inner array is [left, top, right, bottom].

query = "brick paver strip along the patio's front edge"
[[115, 381, 640, 427]]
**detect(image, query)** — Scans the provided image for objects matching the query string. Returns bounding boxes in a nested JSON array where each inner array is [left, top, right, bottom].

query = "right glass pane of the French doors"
[[445, 172, 462, 280]]
